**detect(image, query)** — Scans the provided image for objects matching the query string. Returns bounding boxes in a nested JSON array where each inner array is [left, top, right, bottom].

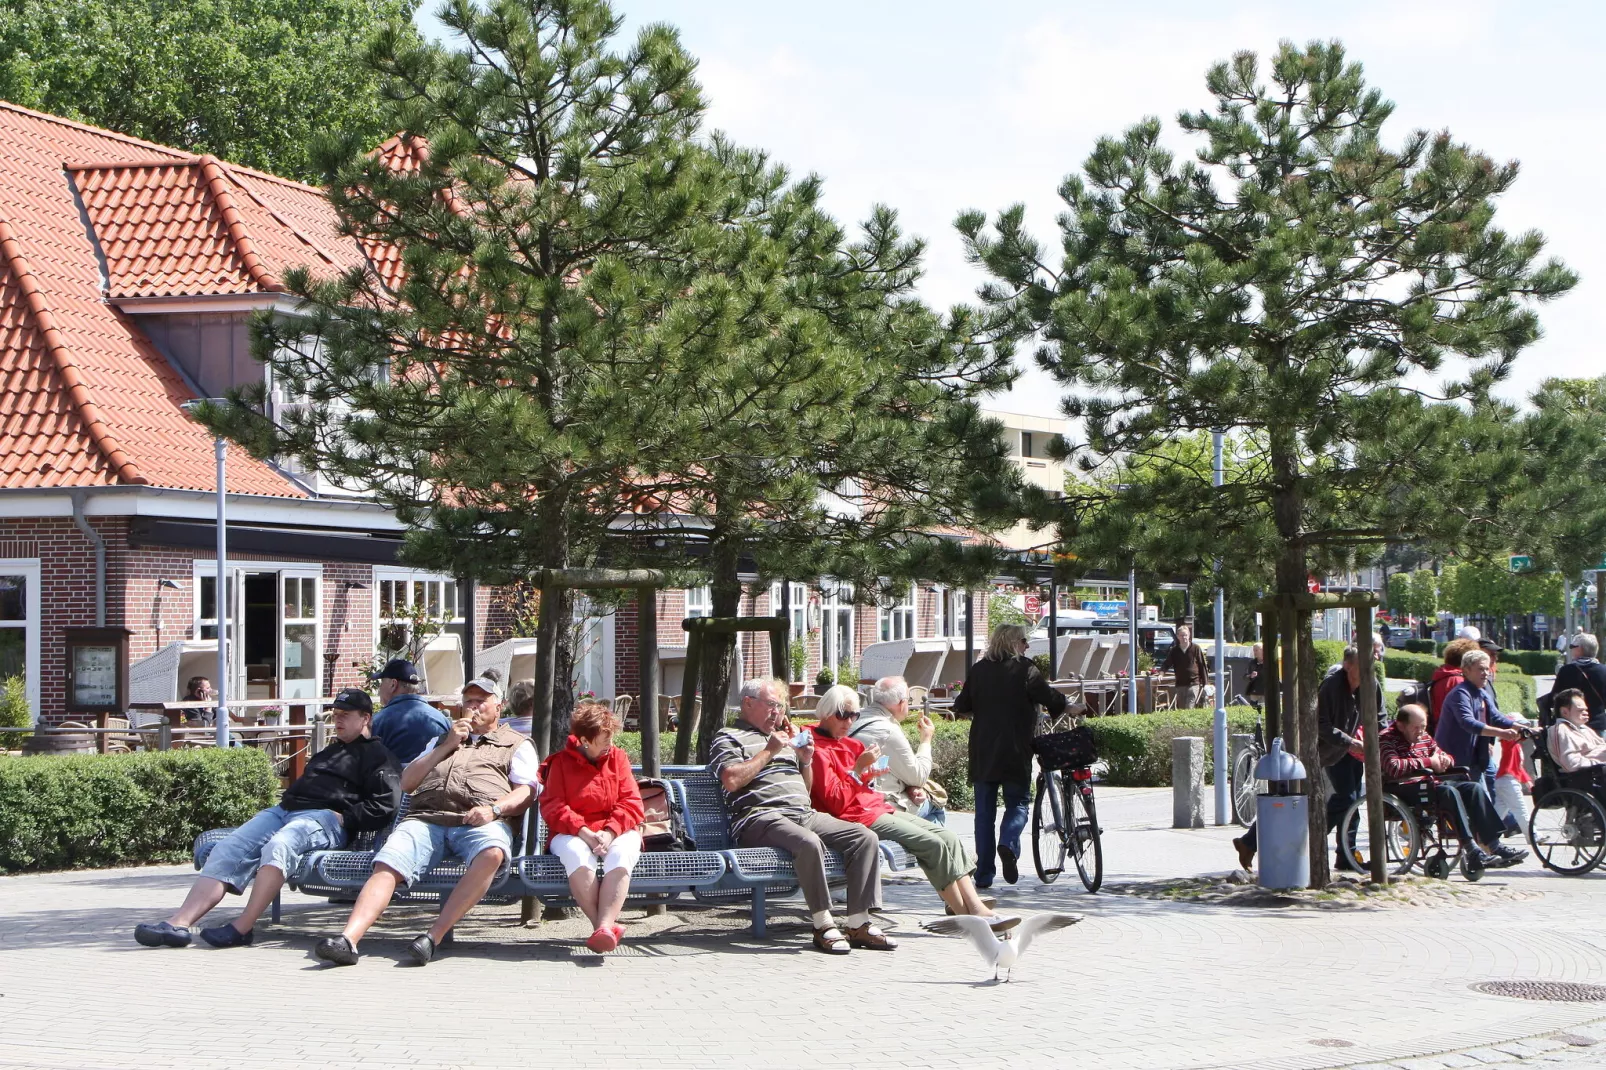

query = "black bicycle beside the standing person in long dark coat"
[[1031, 726, 1103, 892]]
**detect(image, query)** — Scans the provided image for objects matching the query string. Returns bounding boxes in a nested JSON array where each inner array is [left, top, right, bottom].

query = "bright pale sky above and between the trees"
[[419, 0, 1606, 416]]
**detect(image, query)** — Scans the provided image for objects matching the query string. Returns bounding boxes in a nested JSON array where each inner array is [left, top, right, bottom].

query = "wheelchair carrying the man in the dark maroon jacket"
[[1338, 766, 1484, 880]]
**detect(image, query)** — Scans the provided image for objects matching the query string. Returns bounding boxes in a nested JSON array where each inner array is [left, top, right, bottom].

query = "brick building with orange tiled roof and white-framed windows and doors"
[[0, 101, 984, 721]]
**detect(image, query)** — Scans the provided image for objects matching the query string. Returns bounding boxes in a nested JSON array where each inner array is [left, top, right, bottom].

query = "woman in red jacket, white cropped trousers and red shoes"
[[541, 702, 642, 953]]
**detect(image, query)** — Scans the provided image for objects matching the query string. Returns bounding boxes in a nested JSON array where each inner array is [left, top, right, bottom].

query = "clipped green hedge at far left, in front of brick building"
[[0, 747, 279, 872]]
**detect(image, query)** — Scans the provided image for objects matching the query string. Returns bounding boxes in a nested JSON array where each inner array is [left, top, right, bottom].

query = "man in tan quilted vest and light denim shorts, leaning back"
[[315, 676, 541, 966]]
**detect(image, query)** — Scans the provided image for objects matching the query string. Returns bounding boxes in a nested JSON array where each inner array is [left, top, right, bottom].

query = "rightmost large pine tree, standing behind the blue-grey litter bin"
[[959, 42, 1575, 887]]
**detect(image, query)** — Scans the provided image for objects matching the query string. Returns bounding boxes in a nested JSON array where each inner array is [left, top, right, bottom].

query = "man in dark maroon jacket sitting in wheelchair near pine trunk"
[[1378, 704, 1527, 869]]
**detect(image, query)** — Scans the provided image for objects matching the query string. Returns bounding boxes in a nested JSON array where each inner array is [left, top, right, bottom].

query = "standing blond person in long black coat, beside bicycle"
[[954, 625, 1065, 888]]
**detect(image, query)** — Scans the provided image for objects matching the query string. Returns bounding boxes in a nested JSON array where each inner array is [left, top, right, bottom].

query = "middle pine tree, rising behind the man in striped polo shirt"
[[613, 140, 1020, 762]]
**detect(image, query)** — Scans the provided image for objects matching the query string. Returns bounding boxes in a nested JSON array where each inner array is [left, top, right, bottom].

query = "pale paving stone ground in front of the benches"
[[0, 789, 1606, 1070]]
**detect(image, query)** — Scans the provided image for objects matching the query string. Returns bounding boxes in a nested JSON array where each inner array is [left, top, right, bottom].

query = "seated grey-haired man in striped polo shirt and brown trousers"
[[708, 680, 898, 954]]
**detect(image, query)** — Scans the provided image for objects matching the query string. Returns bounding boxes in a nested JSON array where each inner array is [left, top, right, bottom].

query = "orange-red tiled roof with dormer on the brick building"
[[0, 101, 379, 498]]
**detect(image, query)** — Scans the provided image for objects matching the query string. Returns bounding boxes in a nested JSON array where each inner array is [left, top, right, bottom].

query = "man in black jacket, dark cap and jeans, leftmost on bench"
[[133, 688, 402, 948]]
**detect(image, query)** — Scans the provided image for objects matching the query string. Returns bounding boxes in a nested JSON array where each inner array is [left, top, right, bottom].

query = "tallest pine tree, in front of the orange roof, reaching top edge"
[[210, 0, 724, 749]]
